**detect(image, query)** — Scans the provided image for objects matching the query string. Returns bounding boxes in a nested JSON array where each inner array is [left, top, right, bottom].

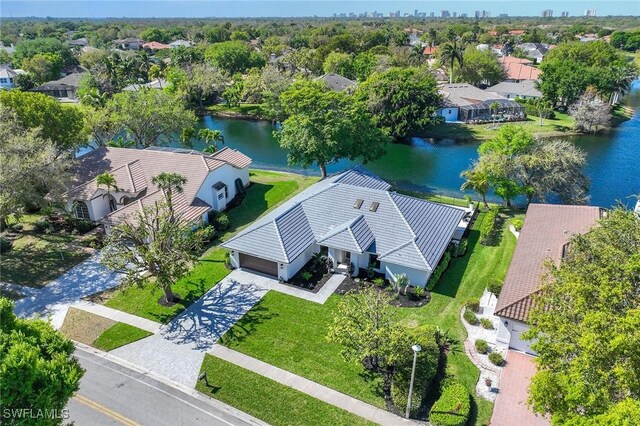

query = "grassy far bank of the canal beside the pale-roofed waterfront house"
[[423, 111, 577, 141]]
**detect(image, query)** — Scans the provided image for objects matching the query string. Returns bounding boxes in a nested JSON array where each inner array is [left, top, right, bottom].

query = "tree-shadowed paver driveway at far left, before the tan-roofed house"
[[14, 253, 122, 317]]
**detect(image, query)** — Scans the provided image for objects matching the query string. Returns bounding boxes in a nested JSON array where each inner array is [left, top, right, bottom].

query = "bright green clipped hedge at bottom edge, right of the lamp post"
[[429, 381, 471, 426]]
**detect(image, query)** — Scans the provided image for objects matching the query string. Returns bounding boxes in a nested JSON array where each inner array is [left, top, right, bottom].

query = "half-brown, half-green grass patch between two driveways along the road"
[[60, 308, 151, 351]]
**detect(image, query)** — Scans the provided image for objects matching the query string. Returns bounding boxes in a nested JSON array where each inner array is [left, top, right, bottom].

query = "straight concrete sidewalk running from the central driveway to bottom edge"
[[207, 345, 416, 426]]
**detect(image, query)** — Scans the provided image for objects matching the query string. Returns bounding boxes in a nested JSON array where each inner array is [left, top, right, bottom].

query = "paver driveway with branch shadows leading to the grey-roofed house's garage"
[[111, 274, 268, 387]]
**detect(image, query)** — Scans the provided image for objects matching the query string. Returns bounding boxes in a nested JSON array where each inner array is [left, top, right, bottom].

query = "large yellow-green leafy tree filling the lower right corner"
[[526, 208, 640, 425]]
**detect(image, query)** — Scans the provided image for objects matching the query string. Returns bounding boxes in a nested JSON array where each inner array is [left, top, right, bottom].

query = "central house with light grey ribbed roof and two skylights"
[[222, 167, 466, 286]]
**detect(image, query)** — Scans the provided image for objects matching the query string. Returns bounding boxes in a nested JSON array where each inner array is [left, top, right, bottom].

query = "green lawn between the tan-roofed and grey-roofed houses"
[[100, 170, 317, 323]]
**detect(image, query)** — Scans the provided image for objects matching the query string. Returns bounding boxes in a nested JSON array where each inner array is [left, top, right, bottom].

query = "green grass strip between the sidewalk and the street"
[[196, 355, 374, 426]]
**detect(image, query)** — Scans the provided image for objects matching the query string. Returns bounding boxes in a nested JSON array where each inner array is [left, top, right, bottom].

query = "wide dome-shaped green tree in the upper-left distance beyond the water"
[[205, 40, 266, 75]]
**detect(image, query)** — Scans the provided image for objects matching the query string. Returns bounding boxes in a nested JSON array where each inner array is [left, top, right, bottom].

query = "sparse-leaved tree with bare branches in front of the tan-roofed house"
[[101, 202, 206, 304]]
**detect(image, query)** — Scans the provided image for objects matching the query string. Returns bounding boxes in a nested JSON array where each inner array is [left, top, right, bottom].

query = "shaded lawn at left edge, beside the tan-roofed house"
[[0, 214, 91, 288]]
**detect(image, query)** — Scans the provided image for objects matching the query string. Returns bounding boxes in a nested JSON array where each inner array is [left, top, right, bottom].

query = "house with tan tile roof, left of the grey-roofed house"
[[64, 147, 251, 227]]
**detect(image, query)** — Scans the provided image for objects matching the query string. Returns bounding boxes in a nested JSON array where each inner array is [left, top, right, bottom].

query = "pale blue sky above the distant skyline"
[[0, 0, 640, 18]]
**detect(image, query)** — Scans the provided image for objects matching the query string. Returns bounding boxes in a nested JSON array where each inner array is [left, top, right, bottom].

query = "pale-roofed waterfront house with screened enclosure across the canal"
[[437, 83, 525, 122]]
